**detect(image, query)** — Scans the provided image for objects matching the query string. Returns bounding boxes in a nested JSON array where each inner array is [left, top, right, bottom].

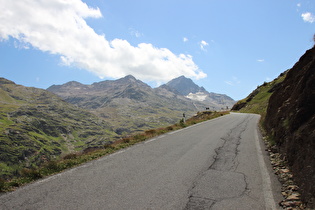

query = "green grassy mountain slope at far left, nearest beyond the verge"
[[0, 78, 117, 178]]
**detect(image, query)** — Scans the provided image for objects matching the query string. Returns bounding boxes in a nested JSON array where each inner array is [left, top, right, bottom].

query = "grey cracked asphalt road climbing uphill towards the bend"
[[0, 114, 280, 210]]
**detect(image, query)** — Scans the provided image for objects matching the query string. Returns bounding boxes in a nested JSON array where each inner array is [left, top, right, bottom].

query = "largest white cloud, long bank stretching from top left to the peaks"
[[0, 0, 207, 83]]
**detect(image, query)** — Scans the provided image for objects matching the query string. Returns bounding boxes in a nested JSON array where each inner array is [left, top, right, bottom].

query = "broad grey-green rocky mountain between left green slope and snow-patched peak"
[[47, 75, 236, 135]]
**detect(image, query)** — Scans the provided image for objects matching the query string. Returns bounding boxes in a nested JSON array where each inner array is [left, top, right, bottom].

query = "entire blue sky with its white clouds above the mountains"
[[0, 0, 315, 100]]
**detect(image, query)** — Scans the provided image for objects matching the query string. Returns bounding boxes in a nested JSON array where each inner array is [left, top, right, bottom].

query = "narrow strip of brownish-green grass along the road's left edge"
[[0, 111, 229, 192]]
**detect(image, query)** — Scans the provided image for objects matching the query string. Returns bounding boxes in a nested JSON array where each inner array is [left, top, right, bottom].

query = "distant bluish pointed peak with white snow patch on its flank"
[[166, 76, 235, 109]]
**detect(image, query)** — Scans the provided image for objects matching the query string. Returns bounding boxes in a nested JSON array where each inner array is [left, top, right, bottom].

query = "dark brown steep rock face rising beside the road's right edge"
[[264, 47, 315, 207]]
